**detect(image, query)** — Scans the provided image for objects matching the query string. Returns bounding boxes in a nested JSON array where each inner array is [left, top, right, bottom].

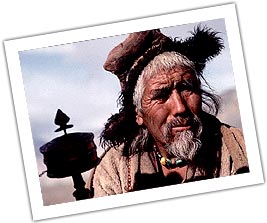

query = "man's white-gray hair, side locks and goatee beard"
[[130, 52, 220, 157]]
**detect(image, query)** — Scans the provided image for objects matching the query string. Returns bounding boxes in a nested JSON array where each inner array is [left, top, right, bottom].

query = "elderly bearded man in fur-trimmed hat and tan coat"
[[90, 26, 248, 197]]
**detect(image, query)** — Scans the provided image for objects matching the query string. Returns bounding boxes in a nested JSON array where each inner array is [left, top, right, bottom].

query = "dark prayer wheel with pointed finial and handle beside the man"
[[39, 109, 100, 200]]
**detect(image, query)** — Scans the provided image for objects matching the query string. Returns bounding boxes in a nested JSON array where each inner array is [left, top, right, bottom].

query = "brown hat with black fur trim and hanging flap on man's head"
[[100, 26, 223, 150]]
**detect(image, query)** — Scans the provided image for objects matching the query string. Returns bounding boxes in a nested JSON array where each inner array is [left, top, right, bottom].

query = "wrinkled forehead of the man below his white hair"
[[145, 68, 196, 87]]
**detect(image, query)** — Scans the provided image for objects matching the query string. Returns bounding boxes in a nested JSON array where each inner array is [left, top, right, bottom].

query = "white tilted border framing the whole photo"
[[4, 4, 264, 220]]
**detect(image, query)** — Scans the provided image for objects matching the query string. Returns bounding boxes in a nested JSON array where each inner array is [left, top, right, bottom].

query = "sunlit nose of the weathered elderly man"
[[169, 89, 187, 117]]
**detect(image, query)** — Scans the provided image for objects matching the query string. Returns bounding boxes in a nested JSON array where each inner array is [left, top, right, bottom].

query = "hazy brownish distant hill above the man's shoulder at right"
[[217, 89, 242, 128]]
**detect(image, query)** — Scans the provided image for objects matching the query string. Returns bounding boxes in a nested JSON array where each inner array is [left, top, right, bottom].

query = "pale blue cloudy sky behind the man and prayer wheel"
[[19, 19, 242, 204]]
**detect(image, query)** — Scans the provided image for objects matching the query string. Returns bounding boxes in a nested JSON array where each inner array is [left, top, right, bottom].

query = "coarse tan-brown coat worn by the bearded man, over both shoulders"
[[88, 124, 248, 197]]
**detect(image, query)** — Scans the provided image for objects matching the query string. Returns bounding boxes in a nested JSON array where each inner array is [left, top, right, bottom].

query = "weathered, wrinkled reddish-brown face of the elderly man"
[[137, 68, 201, 158]]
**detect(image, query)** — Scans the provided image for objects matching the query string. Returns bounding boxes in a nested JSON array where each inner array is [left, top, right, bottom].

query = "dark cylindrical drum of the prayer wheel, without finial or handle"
[[40, 132, 99, 178]]
